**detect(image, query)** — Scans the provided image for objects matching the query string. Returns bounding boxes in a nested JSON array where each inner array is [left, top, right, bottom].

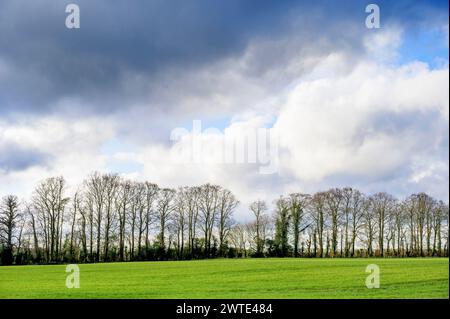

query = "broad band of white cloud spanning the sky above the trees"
[[0, 30, 449, 219]]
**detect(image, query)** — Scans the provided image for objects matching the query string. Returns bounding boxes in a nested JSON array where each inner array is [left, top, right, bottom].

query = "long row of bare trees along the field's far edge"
[[0, 172, 449, 265]]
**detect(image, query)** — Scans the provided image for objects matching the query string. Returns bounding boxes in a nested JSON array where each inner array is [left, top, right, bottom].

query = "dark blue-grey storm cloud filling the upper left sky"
[[0, 0, 298, 112]]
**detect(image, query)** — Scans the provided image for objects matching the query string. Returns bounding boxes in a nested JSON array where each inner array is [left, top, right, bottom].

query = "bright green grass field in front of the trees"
[[0, 258, 449, 299]]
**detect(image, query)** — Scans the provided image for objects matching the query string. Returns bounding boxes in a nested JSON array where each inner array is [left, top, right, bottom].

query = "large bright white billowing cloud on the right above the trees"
[[275, 53, 449, 198]]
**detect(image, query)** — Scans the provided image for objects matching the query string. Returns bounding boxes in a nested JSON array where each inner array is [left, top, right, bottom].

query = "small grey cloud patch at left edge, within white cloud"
[[0, 143, 49, 172]]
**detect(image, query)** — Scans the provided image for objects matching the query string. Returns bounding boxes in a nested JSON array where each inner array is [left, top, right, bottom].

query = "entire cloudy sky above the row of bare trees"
[[0, 0, 449, 220]]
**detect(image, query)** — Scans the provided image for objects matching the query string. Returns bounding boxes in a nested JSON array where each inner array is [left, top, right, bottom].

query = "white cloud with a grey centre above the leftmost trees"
[[0, 116, 114, 198]]
